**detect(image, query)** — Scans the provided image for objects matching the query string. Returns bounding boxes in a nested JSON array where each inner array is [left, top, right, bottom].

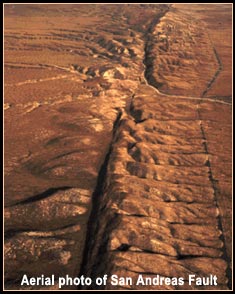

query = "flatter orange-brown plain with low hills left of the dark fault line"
[[4, 5, 167, 289]]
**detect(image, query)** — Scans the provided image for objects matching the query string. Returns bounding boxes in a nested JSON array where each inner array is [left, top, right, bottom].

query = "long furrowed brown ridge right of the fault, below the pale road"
[[83, 87, 231, 290]]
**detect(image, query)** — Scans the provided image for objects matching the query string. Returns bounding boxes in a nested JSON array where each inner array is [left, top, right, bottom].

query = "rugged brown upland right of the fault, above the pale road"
[[145, 5, 231, 100]]
